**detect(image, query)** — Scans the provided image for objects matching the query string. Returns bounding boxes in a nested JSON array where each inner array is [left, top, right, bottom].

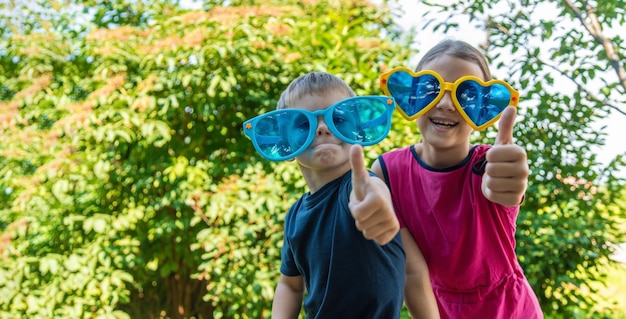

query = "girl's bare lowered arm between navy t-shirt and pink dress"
[[400, 228, 439, 319]]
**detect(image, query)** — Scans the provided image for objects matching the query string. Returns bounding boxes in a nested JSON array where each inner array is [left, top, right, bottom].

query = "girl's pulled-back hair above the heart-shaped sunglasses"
[[415, 39, 491, 81]]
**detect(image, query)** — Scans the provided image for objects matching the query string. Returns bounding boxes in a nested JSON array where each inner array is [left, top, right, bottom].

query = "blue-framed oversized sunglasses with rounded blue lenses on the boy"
[[243, 96, 395, 161]]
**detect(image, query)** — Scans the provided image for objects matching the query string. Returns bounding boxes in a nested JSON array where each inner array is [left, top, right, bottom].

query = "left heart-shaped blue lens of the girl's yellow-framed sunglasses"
[[387, 71, 441, 117]]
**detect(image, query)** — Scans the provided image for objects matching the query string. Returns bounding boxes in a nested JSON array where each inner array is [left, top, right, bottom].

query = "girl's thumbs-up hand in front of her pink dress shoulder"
[[482, 106, 528, 206]]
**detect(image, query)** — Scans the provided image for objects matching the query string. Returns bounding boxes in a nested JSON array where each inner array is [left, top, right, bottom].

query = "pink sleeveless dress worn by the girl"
[[379, 145, 543, 319]]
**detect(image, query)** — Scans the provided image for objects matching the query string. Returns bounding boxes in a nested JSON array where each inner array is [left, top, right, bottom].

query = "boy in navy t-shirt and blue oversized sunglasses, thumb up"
[[244, 72, 405, 319]]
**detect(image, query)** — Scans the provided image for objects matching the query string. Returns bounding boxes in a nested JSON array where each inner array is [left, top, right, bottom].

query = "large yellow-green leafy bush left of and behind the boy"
[[0, 0, 410, 318]]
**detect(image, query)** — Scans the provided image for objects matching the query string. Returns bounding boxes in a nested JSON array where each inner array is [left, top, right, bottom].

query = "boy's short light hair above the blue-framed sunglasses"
[[276, 72, 356, 110]]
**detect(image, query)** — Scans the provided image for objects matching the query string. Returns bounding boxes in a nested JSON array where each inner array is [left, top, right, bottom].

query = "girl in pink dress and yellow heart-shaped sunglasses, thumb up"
[[372, 40, 543, 319]]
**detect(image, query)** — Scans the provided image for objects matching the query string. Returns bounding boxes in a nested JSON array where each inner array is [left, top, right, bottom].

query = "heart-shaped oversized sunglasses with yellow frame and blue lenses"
[[380, 67, 519, 130]]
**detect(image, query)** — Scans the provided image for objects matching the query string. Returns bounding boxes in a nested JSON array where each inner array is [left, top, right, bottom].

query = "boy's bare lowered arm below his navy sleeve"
[[272, 274, 304, 319]]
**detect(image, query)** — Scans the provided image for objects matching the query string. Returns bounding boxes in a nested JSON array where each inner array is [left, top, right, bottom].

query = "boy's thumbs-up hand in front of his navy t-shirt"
[[349, 145, 400, 245]]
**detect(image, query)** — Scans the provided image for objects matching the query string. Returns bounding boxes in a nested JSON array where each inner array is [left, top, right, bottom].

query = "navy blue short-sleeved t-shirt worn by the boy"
[[280, 172, 406, 319]]
